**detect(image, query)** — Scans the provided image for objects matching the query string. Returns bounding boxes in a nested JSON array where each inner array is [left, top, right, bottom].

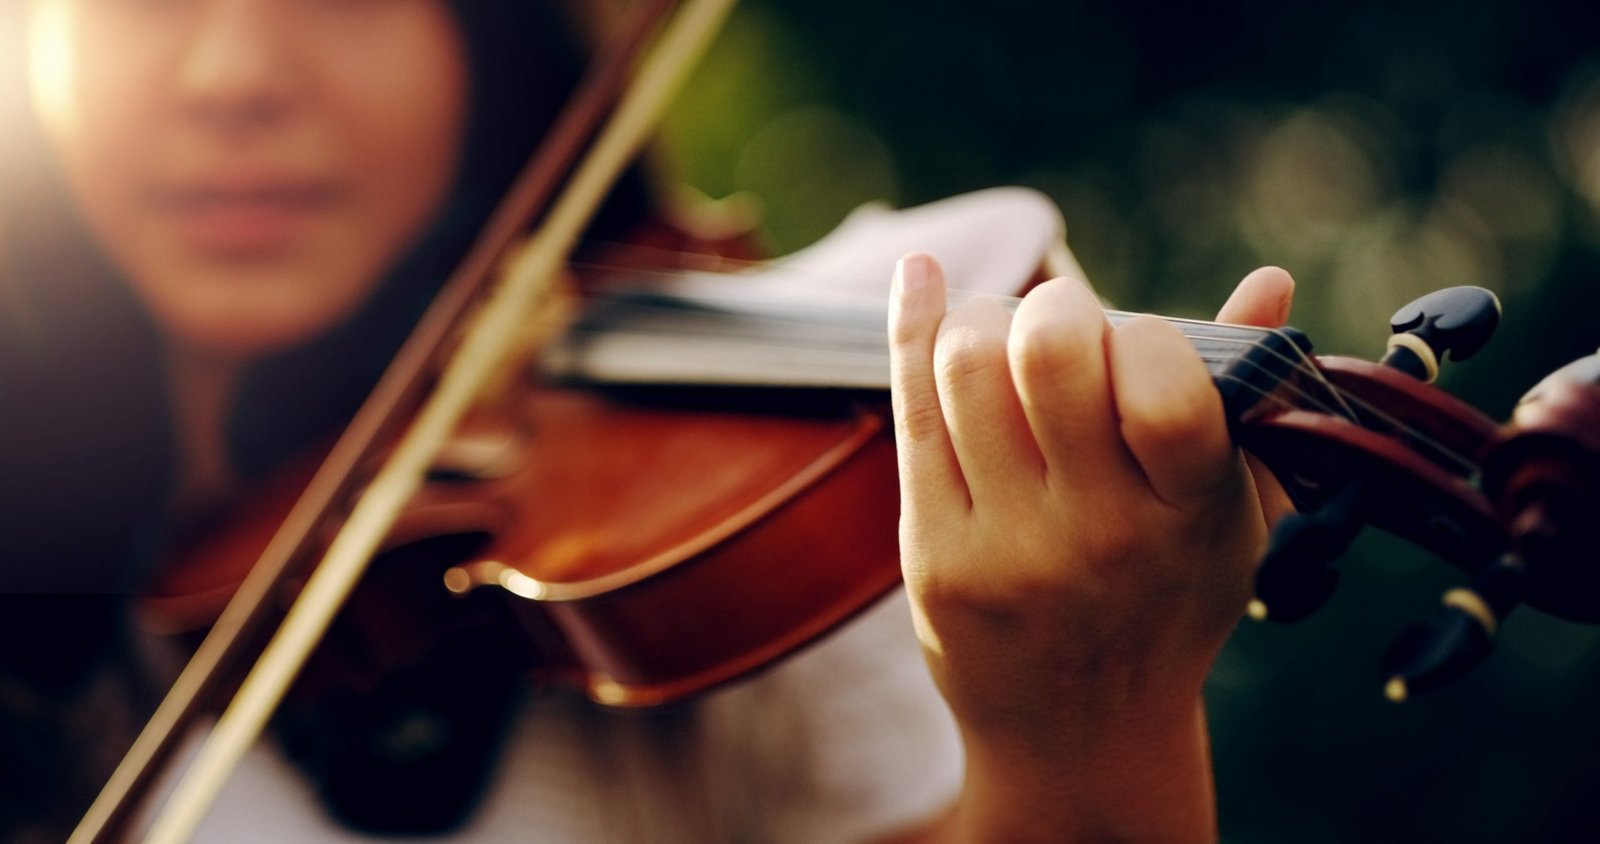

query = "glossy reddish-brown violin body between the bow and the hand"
[[438, 382, 899, 707]]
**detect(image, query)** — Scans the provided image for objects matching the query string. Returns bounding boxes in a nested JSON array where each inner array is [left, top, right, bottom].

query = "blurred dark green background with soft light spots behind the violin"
[[664, 0, 1600, 844]]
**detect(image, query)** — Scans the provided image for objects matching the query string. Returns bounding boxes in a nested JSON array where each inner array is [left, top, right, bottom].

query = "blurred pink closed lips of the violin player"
[[149, 177, 341, 259]]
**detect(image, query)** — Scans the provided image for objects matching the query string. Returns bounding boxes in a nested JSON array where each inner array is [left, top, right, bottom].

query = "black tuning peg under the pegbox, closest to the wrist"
[[1250, 483, 1365, 622]]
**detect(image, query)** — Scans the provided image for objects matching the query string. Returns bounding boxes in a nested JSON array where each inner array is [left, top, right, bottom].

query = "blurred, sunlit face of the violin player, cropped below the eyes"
[[29, 0, 467, 356]]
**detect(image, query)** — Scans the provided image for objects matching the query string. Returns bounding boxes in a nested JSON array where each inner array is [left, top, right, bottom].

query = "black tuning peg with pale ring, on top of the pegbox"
[[1382, 288, 1501, 382]]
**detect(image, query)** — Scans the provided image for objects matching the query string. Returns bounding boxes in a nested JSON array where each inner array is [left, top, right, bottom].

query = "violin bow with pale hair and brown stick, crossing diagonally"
[[69, 0, 734, 844]]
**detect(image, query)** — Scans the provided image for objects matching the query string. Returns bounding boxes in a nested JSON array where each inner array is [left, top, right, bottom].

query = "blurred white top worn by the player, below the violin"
[[195, 591, 962, 844]]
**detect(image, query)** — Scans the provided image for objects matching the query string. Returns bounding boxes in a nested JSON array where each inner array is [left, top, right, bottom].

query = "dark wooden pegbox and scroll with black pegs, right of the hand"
[[1240, 288, 1600, 700]]
